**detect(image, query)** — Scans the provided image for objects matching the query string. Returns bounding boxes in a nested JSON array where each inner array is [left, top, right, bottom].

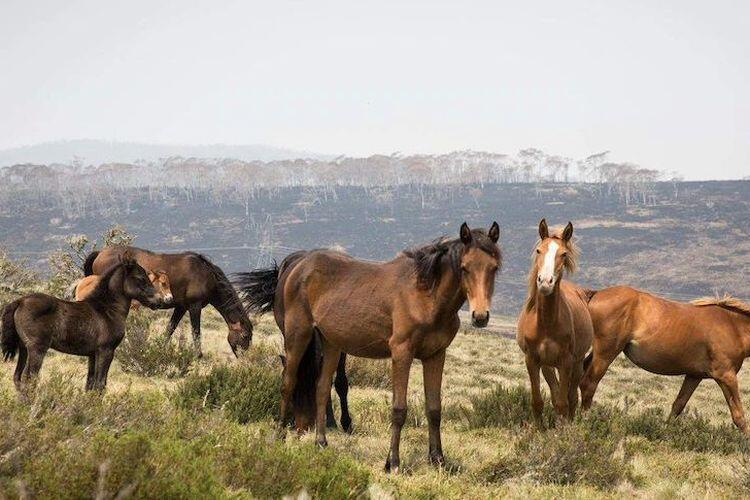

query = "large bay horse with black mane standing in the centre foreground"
[[242, 222, 501, 472]]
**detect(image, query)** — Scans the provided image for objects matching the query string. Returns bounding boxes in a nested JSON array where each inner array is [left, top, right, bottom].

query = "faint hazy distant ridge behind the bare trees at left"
[[0, 139, 333, 167]]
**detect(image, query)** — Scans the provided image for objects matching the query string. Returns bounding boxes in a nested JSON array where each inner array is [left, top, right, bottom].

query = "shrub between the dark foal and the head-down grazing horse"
[[115, 311, 197, 378]]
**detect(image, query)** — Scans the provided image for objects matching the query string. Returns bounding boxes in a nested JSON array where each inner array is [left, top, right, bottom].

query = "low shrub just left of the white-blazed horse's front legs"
[[466, 384, 555, 428]]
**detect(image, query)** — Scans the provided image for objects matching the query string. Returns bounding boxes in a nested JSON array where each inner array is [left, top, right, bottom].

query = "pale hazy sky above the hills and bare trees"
[[0, 0, 750, 178]]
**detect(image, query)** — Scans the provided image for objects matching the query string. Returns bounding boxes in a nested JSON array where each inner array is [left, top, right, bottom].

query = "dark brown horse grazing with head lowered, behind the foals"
[[83, 245, 253, 356]]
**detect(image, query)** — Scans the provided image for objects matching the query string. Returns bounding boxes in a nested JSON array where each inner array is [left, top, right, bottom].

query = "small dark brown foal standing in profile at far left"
[[0, 254, 160, 390]]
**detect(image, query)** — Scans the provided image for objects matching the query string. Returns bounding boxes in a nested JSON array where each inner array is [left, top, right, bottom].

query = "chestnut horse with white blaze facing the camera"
[[516, 219, 593, 425]]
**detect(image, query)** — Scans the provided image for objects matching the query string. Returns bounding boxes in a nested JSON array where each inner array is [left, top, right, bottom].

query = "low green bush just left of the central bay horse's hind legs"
[[174, 362, 281, 423]]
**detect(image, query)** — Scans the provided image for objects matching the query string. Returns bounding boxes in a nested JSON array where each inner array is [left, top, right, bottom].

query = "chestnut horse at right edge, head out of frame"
[[581, 286, 750, 432]]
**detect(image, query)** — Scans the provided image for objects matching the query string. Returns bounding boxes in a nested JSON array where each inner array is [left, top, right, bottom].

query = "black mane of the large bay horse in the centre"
[[403, 229, 503, 290]]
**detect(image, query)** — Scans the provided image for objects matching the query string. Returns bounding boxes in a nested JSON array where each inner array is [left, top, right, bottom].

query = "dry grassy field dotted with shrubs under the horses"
[[0, 310, 750, 498]]
